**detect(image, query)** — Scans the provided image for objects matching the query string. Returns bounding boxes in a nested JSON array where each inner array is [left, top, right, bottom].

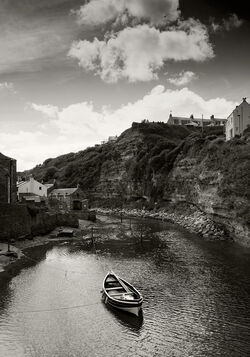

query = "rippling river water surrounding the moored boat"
[[0, 217, 250, 357]]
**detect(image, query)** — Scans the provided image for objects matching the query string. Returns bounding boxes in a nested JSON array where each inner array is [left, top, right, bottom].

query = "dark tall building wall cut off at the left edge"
[[0, 153, 17, 203]]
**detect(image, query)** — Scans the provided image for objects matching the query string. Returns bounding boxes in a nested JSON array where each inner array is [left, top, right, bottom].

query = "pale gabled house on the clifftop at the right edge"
[[226, 98, 250, 140]]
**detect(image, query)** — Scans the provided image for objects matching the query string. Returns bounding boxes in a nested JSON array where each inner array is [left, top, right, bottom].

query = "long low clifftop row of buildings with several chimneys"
[[167, 114, 227, 127]]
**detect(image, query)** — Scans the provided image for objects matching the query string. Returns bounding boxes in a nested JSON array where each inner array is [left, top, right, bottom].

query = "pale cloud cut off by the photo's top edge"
[[74, 0, 179, 26]]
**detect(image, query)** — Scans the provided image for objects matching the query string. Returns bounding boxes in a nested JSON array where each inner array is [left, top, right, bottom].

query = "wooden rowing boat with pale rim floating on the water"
[[102, 272, 143, 316]]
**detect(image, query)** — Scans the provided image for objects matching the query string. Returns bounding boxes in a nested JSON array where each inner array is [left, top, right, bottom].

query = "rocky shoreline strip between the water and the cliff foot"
[[0, 208, 228, 278]]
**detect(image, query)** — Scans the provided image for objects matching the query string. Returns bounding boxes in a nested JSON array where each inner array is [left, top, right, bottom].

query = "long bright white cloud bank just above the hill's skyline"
[[0, 85, 236, 170]]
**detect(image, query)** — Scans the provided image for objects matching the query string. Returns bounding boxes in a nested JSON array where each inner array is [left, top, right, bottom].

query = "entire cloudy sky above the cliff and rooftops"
[[0, 0, 250, 171]]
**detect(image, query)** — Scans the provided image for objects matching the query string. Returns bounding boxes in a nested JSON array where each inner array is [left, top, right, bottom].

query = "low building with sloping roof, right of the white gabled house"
[[49, 187, 88, 210]]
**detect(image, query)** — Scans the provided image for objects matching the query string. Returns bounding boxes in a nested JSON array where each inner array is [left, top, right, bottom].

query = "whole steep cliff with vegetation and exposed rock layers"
[[23, 122, 250, 246]]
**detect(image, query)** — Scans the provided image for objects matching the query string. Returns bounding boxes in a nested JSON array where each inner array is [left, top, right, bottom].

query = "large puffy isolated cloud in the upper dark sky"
[[68, 19, 214, 82]]
